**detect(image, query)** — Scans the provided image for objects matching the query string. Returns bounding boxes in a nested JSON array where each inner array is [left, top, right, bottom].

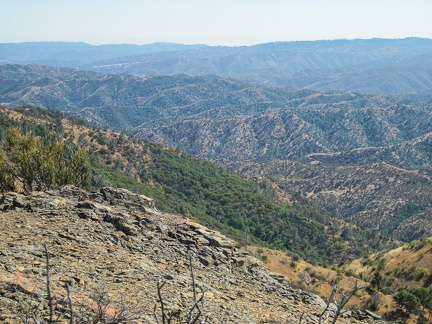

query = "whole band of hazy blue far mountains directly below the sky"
[[0, 38, 432, 94]]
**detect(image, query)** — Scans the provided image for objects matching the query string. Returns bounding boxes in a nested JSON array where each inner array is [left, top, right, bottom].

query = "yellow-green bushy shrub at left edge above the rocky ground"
[[0, 128, 90, 193]]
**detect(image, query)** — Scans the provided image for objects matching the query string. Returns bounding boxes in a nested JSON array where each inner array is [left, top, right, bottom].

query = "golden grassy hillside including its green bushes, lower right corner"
[[248, 238, 432, 324]]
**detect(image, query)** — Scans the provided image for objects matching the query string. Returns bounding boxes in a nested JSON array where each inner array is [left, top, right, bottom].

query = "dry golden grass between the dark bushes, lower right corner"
[[245, 239, 432, 323]]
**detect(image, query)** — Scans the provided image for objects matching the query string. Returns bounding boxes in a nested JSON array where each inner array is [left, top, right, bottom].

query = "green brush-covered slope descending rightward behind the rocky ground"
[[0, 108, 393, 263]]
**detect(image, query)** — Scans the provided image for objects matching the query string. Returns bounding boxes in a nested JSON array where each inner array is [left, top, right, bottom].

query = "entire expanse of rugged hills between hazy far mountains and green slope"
[[0, 65, 432, 240]]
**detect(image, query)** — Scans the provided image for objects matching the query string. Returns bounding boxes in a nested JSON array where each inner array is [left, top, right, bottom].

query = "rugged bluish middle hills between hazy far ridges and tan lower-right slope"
[[0, 65, 432, 164]]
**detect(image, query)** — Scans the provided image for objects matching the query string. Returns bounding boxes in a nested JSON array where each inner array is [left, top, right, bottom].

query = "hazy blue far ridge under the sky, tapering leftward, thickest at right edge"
[[85, 38, 432, 94]]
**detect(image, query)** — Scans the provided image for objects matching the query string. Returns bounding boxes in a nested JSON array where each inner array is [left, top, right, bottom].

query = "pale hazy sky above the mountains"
[[0, 0, 432, 46]]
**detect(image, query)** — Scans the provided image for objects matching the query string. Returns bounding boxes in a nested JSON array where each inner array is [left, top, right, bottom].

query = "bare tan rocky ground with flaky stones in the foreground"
[[0, 186, 392, 323]]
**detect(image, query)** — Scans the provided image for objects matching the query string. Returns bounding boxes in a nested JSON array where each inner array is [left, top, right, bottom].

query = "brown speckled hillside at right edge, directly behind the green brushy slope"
[[220, 161, 432, 240]]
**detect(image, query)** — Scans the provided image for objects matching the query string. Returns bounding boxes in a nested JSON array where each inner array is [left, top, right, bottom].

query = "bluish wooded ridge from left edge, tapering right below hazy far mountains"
[[0, 65, 316, 129]]
